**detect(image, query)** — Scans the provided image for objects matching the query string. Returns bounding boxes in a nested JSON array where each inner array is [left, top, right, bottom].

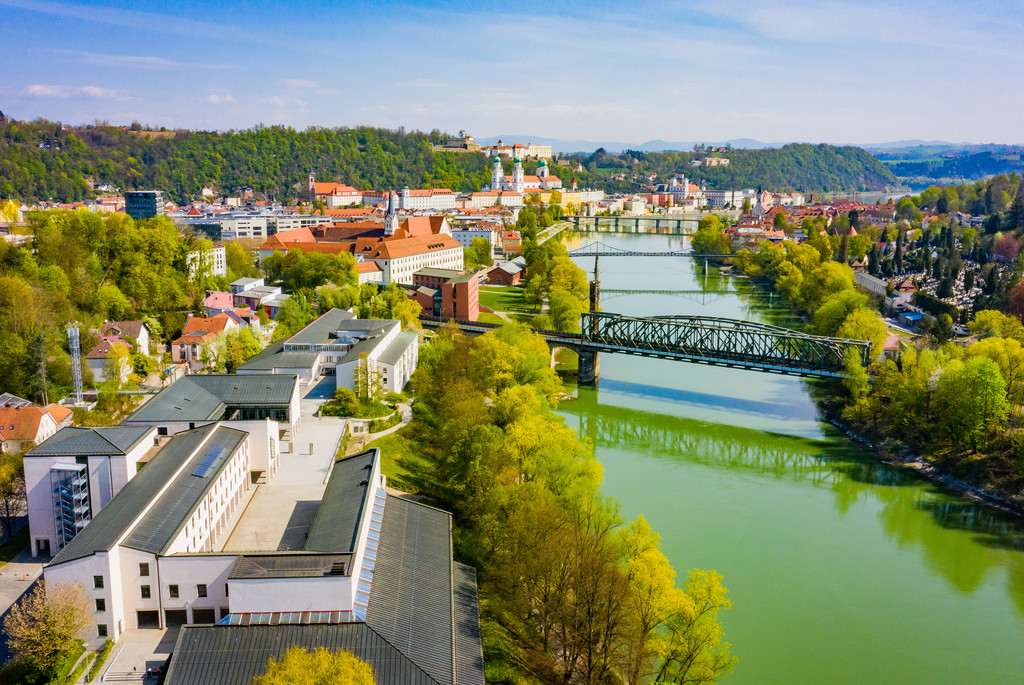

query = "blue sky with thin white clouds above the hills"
[[0, 0, 1024, 143]]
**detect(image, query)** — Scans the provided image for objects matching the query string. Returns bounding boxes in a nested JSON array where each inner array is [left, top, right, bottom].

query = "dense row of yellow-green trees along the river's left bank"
[[413, 325, 735, 684]]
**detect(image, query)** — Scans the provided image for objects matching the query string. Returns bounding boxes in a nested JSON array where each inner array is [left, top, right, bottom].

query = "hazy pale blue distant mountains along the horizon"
[[476, 134, 1015, 154]]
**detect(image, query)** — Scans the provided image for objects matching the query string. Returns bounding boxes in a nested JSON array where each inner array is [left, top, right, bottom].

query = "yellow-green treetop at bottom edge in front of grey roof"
[[253, 646, 374, 685]]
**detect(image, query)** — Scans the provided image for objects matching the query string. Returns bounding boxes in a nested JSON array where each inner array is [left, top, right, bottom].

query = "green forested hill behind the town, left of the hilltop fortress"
[[0, 121, 490, 203]]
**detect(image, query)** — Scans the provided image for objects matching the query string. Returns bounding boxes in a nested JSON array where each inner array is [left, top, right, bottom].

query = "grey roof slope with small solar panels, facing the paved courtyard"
[[119, 424, 249, 554]]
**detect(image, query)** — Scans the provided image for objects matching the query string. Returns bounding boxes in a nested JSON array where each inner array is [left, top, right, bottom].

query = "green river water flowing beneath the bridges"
[[559, 233, 1024, 684]]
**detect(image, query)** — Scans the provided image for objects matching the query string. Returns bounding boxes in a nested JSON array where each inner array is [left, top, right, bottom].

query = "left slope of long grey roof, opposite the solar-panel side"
[[50, 425, 216, 566]]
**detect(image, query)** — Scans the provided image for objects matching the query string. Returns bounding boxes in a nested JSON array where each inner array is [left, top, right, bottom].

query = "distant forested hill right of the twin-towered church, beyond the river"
[[574, 143, 898, 192]]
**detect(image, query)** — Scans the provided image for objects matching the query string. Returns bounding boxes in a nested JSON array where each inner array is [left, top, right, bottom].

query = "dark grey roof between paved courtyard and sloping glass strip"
[[306, 449, 380, 554]]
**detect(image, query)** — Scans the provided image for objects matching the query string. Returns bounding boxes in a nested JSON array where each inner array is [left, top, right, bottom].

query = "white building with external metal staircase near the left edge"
[[25, 426, 157, 557]]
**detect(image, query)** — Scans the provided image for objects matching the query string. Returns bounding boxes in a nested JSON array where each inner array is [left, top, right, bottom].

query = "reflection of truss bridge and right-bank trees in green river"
[[559, 389, 1024, 615]]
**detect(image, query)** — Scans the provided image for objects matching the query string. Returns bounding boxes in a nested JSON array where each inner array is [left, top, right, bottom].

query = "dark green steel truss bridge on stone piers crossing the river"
[[420, 311, 870, 383]]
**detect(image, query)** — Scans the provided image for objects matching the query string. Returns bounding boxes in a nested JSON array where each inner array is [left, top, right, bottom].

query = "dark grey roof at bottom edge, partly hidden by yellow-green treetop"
[[165, 623, 437, 685]]
